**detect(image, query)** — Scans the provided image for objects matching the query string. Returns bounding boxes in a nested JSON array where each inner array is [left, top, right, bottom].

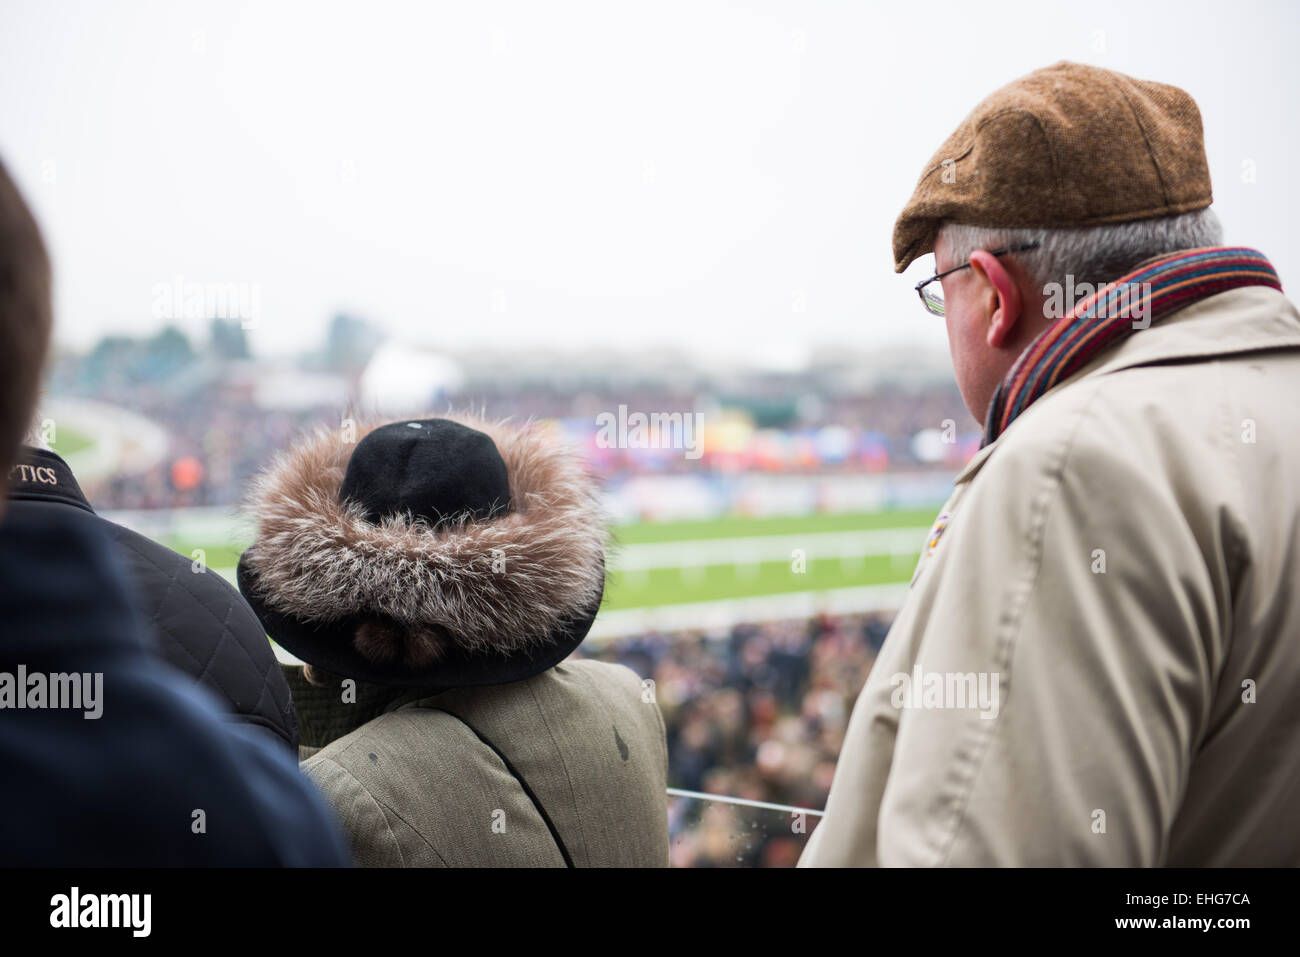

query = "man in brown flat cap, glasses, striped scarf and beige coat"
[[801, 62, 1300, 866]]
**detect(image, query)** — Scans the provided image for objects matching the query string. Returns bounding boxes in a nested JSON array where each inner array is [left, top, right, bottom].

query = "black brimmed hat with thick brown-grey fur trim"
[[238, 417, 607, 690]]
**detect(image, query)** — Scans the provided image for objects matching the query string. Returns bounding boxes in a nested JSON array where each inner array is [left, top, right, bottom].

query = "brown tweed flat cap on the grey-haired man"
[[893, 61, 1213, 273]]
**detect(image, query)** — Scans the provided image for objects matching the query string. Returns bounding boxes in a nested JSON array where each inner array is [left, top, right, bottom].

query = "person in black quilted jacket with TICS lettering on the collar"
[[9, 447, 298, 755]]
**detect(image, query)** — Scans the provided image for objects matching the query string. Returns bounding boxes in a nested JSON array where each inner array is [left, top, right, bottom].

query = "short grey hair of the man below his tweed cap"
[[940, 207, 1223, 293]]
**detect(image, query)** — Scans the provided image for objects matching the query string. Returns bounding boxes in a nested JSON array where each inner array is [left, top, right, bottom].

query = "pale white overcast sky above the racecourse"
[[0, 0, 1300, 360]]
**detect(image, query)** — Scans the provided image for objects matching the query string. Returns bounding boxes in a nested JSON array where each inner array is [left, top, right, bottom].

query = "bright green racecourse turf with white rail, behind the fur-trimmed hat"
[[168, 508, 936, 609]]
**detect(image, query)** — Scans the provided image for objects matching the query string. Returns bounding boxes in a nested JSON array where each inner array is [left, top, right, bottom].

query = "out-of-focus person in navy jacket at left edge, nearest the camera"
[[0, 157, 347, 866]]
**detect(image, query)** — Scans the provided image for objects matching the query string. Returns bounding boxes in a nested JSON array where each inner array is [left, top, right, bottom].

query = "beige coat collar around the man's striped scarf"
[[953, 286, 1300, 485]]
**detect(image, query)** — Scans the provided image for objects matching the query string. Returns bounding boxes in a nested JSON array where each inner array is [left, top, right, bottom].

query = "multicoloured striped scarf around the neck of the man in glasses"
[[980, 246, 1282, 447]]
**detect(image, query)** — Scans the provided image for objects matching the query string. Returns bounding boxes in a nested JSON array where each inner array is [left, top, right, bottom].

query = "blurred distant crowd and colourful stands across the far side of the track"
[[49, 322, 979, 508]]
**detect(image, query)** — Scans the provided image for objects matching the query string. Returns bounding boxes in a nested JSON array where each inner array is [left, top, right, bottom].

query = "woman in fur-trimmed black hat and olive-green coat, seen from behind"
[[239, 416, 668, 866]]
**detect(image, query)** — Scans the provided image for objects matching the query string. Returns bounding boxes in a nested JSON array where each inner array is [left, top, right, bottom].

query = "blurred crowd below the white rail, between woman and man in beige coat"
[[586, 614, 892, 867]]
